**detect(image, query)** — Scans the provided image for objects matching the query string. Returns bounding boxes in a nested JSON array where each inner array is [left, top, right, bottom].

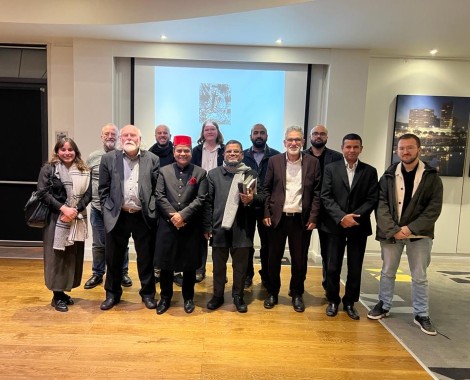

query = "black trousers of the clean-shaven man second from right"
[[325, 233, 367, 305]]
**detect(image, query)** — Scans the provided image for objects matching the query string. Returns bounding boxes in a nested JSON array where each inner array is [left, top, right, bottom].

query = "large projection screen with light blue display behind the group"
[[135, 60, 307, 151]]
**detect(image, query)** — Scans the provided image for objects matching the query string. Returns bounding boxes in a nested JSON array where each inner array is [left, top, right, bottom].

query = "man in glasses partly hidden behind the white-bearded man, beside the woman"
[[84, 123, 132, 289]]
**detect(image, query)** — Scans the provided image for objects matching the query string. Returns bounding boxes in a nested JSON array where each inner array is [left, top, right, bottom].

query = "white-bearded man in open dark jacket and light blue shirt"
[[98, 125, 159, 310]]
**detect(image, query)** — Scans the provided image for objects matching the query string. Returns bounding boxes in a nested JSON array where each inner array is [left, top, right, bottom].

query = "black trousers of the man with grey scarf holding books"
[[212, 247, 249, 297]]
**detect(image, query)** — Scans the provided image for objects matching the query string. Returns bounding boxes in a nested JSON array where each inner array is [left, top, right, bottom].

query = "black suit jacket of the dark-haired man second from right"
[[320, 160, 379, 236]]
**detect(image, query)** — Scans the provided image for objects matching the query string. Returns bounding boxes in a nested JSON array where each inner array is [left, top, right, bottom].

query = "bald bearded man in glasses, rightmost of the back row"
[[303, 124, 343, 290]]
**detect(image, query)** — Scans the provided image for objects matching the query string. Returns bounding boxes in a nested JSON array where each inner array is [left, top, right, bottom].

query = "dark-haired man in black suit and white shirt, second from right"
[[320, 133, 378, 320]]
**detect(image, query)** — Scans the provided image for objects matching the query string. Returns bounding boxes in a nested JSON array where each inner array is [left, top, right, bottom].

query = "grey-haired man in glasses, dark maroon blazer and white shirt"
[[263, 126, 321, 312]]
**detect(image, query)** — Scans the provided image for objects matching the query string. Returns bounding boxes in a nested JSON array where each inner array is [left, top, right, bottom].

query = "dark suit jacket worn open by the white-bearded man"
[[98, 150, 160, 233]]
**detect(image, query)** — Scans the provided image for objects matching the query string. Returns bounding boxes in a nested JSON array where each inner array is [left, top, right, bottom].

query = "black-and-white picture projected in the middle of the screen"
[[199, 83, 232, 124]]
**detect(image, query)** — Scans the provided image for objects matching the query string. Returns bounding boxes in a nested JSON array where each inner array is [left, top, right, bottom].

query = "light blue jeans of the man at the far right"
[[379, 237, 432, 317]]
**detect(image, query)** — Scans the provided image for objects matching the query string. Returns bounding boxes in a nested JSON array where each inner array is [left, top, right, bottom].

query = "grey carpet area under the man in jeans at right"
[[361, 253, 470, 380]]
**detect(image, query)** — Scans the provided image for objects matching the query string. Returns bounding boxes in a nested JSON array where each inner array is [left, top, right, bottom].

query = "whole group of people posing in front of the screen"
[[38, 120, 443, 335]]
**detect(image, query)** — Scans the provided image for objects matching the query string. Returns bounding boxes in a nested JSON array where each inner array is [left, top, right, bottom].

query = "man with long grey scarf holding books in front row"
[[204, 140, 263, 313]]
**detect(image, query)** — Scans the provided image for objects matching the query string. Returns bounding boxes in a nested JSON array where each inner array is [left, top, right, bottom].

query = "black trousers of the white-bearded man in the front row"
[[104, 211, 155, 301]]
